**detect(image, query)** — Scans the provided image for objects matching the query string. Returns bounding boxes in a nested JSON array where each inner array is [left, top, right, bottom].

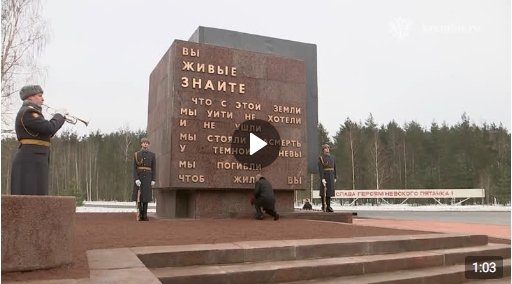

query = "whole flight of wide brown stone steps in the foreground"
[[139, 234, 510, 284]]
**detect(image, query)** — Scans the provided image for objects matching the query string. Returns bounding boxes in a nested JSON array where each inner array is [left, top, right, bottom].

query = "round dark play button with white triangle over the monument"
[[231, 119, 281, 169]]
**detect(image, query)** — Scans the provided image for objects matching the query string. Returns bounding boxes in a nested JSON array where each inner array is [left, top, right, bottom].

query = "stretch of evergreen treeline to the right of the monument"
[[318, 114, 511, 204]]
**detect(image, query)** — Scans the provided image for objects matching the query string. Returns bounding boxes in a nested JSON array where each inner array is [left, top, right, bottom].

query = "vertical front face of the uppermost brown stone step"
[[132, 234, 488, 269]]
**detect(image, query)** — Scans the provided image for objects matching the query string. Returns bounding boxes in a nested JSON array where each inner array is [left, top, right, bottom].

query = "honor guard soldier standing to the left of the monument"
[[132, 138, 156, 221]]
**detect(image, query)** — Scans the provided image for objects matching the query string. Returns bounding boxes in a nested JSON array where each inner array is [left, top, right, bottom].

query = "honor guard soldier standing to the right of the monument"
[[318, 144, 336, 212]]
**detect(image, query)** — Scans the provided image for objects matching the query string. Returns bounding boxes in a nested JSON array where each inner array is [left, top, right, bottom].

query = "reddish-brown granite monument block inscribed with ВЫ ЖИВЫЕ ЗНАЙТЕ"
[[148, 41, 307, 194]]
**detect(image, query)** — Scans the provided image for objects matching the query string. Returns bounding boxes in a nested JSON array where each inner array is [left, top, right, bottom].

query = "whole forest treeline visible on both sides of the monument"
[[1, 114, 511, 204]]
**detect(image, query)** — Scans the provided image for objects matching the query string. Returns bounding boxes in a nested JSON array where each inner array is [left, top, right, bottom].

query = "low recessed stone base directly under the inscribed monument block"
[[153, 189, 294, 219]]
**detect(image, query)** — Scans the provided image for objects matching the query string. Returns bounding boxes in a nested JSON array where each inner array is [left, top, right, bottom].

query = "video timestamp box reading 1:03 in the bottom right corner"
[[464, 256, 503, 279]]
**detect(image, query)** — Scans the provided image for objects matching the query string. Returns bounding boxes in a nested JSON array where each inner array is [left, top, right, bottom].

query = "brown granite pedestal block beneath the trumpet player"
[[2, 195, 76, 272]]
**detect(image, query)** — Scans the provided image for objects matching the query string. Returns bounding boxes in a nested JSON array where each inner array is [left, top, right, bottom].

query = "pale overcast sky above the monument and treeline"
[[12, 0, 511, 136]]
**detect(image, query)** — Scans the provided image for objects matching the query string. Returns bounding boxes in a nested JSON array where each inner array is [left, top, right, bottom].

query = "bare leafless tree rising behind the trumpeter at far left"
[[1, 0, 50, 128]]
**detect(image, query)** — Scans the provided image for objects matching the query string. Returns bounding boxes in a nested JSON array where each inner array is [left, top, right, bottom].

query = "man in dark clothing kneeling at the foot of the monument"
[[254, 174, 279, 221]]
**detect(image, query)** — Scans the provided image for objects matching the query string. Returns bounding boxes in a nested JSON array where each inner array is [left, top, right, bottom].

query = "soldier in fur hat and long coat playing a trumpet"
[[11, 85, 68, 195]]
